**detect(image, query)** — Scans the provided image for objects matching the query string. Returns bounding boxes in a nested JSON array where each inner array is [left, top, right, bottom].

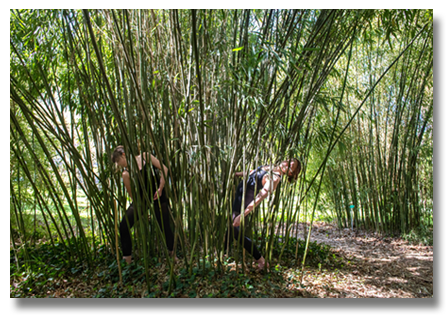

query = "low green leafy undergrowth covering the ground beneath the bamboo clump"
[[10, 236, 344, 298]]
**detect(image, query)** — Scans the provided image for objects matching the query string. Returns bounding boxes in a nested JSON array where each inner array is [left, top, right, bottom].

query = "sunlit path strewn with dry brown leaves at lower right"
[[291, 223, 433, 298]]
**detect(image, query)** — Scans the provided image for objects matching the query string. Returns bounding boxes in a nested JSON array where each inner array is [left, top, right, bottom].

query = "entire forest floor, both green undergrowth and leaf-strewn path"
[[10, 223, 433, 298]]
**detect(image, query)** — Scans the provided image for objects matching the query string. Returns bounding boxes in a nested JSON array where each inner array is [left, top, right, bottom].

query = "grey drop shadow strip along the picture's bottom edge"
[[9, 296, 445, 315]]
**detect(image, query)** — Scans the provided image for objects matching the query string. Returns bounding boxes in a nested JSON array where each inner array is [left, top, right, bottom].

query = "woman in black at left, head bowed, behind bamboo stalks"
[[112, 146, 177, 264]]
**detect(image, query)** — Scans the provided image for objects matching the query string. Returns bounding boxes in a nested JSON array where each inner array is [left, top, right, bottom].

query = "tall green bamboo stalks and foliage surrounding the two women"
[[9, 10, 433, 284]]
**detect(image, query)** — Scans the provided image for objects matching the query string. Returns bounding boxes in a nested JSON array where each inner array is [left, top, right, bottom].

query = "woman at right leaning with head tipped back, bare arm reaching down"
[[225, 158, 301, 270]]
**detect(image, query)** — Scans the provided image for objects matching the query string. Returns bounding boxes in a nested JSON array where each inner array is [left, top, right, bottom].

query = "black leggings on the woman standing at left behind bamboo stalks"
[[120, 202, 174, 257]]
